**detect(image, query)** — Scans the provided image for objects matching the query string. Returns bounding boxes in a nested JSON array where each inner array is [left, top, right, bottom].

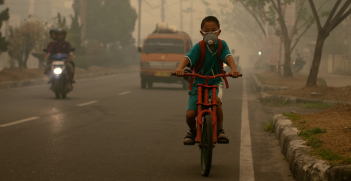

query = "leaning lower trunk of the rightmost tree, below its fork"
[[306, 35, 327, 87]]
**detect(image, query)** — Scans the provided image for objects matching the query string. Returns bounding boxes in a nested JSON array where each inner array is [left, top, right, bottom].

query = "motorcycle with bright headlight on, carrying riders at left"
[[50, 54, 72, 99]]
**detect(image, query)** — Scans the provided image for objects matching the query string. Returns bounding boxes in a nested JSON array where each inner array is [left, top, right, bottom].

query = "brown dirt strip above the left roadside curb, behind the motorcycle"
[[0, 66, 138, 82]]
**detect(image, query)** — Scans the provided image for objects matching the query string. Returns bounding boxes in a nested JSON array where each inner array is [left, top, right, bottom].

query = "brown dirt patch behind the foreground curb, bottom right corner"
[[286, 105, 351, 165]]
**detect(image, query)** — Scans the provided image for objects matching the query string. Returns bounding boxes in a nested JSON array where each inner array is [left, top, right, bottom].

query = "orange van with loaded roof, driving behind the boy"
[[138, 23, 193, 89]]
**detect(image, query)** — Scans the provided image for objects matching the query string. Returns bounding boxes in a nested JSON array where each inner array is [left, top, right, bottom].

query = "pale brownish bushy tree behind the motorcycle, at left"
[[8, 21, 47, 68]]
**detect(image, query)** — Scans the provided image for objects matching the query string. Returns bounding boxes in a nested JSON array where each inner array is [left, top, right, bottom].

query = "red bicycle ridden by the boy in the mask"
[[172, 73, 242, 177]]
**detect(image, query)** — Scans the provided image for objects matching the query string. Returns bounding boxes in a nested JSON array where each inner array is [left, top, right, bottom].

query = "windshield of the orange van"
[[143, 38, 184, 54]]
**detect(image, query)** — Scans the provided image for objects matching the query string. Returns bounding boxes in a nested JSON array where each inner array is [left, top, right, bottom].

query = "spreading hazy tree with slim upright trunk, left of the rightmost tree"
[[233, 0, 314, 77]]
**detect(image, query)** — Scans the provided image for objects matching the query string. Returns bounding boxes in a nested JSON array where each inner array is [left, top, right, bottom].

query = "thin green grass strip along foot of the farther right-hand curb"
[[261, 100, 336, 110]]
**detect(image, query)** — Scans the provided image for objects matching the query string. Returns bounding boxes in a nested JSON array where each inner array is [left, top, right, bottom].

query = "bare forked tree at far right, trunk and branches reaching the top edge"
[[306, 0, 351, 87]]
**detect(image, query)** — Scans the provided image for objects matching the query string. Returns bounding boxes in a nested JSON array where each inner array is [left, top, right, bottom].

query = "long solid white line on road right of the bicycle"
[[239, 78, 255, 181]]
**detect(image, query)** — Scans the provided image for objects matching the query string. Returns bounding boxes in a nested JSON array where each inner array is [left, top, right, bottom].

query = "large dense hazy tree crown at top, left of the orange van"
[[86, 0, 137, 47]]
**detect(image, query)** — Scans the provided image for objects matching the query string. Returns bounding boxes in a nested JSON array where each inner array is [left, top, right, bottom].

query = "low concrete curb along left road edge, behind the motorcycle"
[[0, 68, 139, 89]]
